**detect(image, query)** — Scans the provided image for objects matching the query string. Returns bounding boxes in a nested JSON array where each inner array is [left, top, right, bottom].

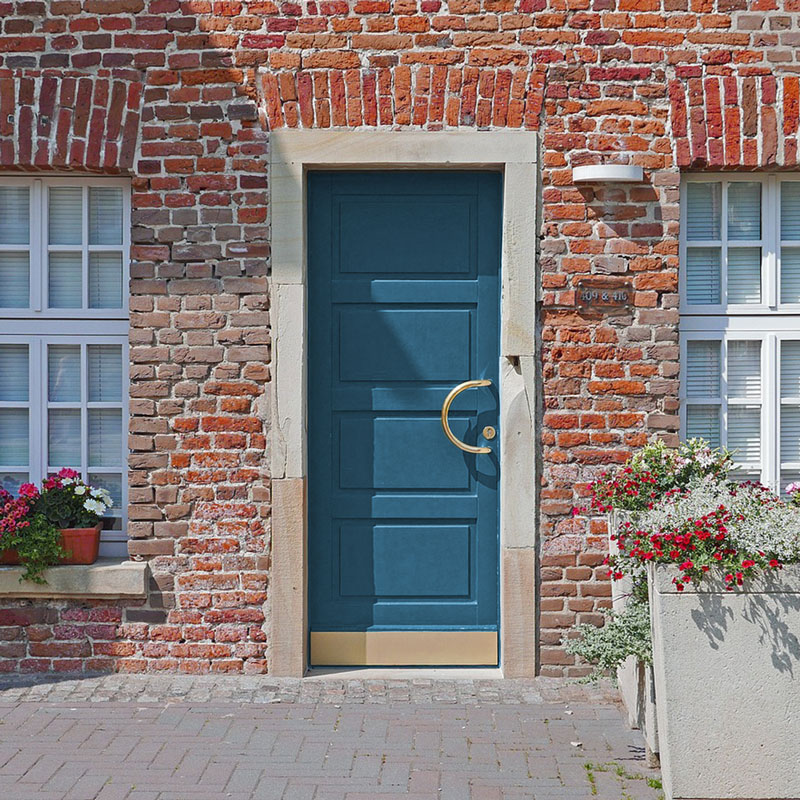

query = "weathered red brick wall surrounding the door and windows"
[[0, 0, 800, 674]]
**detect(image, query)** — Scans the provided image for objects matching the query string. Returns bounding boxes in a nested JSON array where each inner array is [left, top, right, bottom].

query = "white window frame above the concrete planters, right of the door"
[[679, 173, 800, 491]]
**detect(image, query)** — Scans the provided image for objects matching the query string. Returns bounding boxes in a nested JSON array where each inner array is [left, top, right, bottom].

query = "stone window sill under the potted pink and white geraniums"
[[0, 558, 148, 600]]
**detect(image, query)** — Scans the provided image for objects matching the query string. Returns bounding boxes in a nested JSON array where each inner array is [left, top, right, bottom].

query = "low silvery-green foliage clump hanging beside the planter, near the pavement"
[[564, 597, 653, 681]]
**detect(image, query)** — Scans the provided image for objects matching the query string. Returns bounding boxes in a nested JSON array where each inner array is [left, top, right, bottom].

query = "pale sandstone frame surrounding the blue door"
[[267, 129, 539, 678]]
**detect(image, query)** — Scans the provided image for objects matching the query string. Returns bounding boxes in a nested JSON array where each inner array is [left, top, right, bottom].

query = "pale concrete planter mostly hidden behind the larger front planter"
[[608, 510, 659, 765]]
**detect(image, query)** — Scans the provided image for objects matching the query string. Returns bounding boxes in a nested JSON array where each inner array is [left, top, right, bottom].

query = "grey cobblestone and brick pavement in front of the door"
[[0, 675, 661, 800]]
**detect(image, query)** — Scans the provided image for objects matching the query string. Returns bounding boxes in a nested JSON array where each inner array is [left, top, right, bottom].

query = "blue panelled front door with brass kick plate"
[[307, 171, 502, 664]]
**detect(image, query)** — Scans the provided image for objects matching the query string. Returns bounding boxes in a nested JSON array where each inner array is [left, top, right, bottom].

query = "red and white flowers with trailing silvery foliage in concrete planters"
[[565, 439, 800, 679]]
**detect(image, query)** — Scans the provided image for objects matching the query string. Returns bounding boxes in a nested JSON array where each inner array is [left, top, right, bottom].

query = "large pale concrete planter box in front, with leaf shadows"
[[649, 565, 800, 800]]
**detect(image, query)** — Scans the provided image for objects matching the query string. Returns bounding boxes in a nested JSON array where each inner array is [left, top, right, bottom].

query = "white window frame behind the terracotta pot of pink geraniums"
[[0, 175, 131, 557]]
